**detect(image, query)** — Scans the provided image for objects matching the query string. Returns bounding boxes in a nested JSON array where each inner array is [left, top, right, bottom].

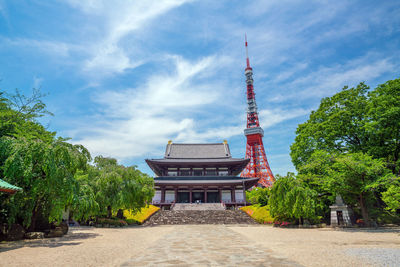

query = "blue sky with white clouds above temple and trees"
[[0, 0, 400, 175]]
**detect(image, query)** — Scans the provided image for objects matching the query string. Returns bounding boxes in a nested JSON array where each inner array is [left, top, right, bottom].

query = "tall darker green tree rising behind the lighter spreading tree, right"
[[290, 83, 369, 169]]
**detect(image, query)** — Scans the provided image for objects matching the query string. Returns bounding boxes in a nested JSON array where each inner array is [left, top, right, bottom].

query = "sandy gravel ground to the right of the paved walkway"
[[230, 227, 400, 267]]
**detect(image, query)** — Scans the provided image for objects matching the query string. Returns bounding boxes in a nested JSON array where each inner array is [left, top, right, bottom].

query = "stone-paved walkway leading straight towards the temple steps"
[[122, 225, 301, 266]]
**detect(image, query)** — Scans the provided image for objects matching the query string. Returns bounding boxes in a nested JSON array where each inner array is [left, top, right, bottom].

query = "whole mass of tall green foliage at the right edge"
[[291, 79, 400, 226]]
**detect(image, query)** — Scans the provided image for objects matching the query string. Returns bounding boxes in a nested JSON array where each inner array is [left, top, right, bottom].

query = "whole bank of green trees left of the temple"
[[0, 90, 154, 230]]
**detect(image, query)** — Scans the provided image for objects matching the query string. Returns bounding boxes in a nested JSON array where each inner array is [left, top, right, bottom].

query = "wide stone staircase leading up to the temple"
[[143, 210, 258, 226]]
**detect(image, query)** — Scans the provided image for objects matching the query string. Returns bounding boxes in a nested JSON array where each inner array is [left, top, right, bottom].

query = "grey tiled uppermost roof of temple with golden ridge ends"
[[164, 142, 232, 159]]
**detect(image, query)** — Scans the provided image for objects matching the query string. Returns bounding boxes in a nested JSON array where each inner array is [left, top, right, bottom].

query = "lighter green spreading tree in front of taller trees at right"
[[299, 151, 393, 224]]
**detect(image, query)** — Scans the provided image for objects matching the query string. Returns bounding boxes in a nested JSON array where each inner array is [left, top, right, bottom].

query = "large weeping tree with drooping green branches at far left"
[[0, 137, 90, 231]]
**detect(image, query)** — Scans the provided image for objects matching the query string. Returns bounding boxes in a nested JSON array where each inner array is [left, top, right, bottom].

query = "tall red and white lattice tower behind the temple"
[[241, 36, 275, 187]]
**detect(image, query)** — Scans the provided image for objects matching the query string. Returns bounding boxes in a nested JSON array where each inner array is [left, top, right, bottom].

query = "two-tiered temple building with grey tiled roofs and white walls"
[[146, 141, 258, 207]]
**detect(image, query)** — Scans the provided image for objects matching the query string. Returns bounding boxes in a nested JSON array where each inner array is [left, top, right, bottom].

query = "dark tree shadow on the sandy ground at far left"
[[0, 231, 99, 253]]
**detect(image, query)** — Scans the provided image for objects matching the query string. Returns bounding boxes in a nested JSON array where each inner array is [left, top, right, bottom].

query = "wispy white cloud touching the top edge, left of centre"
[[67, 0, 194, 76]]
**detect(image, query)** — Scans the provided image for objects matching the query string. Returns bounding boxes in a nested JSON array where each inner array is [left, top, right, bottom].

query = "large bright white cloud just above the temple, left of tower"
[[72, 56, 219, 158]]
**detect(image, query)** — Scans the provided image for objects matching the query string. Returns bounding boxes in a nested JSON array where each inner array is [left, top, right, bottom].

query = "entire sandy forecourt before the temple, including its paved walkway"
[[0, 225, 400, 266]]
